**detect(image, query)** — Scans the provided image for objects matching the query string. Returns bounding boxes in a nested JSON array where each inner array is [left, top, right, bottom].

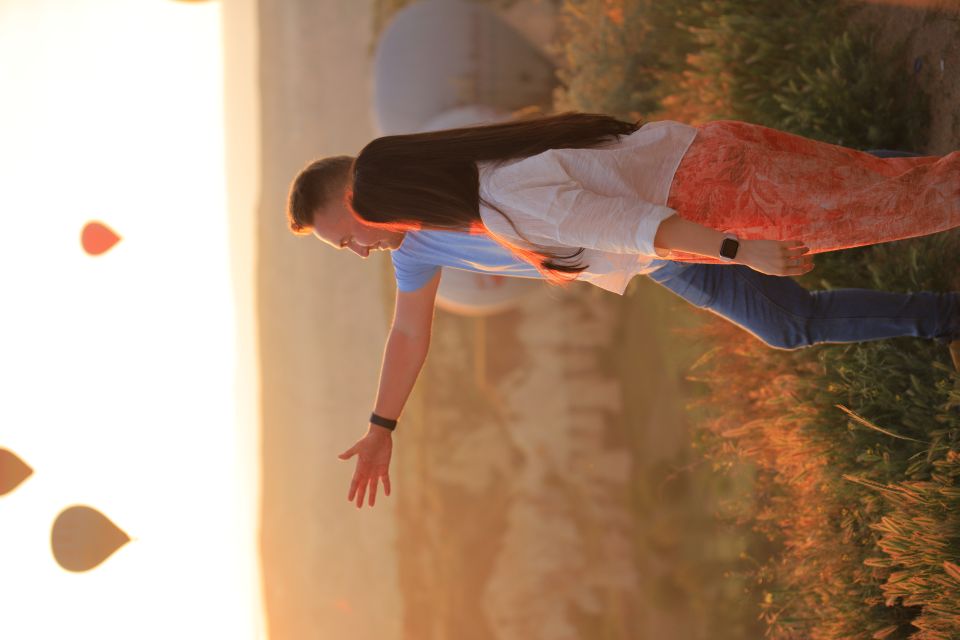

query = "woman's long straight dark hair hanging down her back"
[[351, 112, 640, 284]]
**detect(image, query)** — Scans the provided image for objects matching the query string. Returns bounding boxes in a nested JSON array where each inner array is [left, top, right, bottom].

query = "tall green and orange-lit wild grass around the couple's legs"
[[555, 0, 960, 639]]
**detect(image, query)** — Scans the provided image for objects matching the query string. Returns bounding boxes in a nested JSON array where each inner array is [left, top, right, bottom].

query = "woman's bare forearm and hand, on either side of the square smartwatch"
[[653, 215, 813, 276]]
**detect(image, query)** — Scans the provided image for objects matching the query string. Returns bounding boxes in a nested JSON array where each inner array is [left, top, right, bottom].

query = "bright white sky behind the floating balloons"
[[0, 0, 262, 640]]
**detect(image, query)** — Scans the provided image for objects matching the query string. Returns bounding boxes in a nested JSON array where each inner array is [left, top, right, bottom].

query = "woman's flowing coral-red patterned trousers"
[[667, 120, 960, 263]]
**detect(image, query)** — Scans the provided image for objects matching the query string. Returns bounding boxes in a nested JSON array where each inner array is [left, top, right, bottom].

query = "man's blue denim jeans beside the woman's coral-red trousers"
[[649, 150, 960, 349]]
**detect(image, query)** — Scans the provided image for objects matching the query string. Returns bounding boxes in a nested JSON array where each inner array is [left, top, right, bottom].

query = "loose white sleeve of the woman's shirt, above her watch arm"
[[491, 154, 676, 257]]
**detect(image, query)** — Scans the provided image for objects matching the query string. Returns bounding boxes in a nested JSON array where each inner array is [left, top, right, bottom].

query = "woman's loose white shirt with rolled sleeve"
[[478, 120, 697, 295]]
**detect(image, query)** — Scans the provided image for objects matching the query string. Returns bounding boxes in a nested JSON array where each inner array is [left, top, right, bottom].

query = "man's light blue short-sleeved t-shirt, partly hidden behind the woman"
[[390, 230, 543, 292]]
